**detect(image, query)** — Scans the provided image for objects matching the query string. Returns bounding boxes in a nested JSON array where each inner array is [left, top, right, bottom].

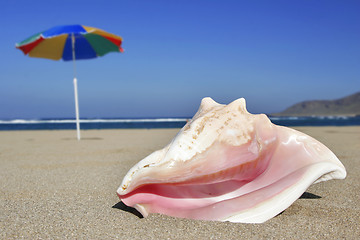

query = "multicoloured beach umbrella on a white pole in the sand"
[[16, 25, 123, 140]]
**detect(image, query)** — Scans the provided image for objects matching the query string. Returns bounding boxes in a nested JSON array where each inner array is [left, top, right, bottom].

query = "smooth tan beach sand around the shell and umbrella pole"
[[0, 127, 360, 239]]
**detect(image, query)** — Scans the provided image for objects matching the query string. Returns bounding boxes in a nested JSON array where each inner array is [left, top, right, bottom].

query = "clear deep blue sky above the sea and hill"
[[0, 0, 360, 119]]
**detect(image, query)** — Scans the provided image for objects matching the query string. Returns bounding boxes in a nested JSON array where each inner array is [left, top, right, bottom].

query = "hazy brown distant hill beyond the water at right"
[[271, 92, 360, 116]]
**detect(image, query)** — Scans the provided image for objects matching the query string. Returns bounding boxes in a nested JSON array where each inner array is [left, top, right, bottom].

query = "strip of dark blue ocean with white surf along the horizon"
[[0, 116, 360, 131]]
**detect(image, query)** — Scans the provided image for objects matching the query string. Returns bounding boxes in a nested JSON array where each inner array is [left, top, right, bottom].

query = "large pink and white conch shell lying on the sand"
[[117, 98, 346, 223]]
